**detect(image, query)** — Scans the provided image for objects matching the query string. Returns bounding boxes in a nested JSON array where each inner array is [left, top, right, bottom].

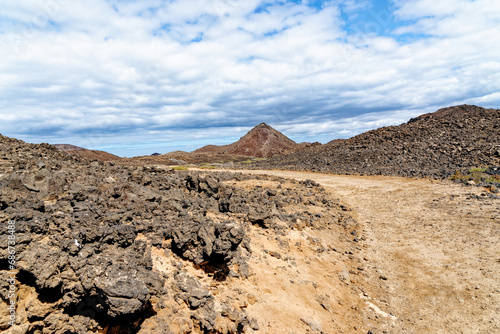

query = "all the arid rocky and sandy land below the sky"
[[0, 106, 500, 334]]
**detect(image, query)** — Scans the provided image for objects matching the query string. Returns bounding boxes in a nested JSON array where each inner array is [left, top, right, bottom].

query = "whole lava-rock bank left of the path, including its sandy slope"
[[0, 136, 359, 333]]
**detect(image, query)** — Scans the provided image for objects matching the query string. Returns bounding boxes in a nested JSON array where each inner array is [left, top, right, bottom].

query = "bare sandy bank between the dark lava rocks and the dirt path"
[[145, 175, 367, 334]]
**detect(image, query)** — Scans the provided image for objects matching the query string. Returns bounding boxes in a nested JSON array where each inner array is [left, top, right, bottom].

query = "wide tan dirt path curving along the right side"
[[201, 171, 500, 333]]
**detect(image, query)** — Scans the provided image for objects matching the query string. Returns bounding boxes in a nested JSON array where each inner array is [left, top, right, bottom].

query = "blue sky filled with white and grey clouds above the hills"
[[0, 0, 500, 156]]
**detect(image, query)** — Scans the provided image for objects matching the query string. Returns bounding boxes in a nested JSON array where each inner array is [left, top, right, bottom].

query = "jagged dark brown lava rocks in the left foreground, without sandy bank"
[[0, 136, 354, 333]]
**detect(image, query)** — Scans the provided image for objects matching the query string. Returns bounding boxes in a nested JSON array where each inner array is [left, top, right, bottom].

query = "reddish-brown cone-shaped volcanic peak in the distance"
[[192, 123, 307, 158]]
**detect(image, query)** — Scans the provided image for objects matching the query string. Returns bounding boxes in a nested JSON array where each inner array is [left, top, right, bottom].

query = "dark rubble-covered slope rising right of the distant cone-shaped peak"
[[258, 105, 500, 178]]
